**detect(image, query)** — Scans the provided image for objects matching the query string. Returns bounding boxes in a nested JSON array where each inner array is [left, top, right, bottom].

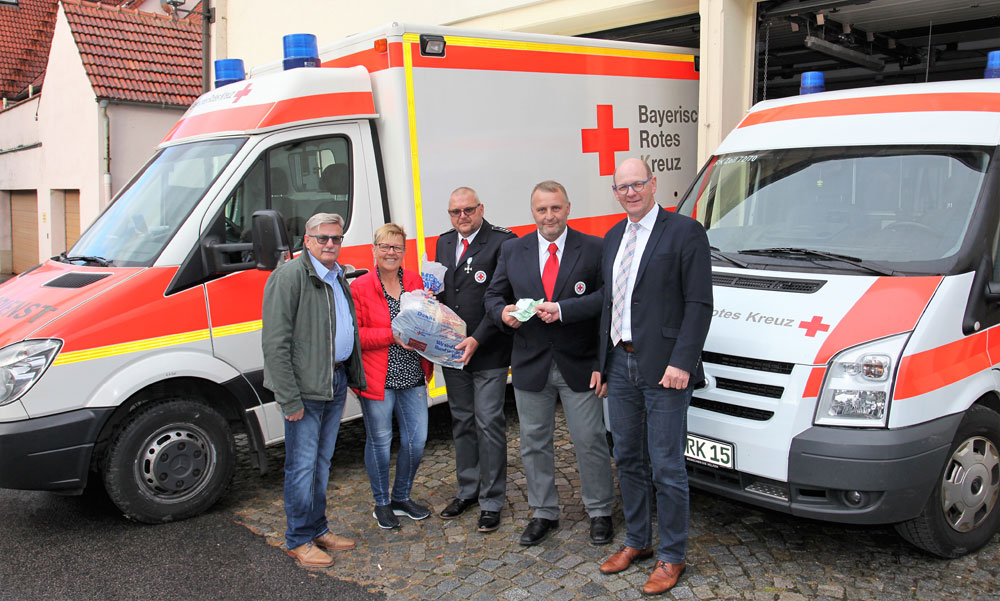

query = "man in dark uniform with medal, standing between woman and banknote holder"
[[435, 187, 516, 532]]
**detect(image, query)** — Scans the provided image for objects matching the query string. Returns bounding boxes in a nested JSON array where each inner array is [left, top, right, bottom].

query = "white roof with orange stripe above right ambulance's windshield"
[[716, 79, 1000, 154]]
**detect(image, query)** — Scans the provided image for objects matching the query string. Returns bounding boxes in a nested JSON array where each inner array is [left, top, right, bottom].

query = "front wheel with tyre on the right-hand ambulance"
[[896, 405, 1000, 558]]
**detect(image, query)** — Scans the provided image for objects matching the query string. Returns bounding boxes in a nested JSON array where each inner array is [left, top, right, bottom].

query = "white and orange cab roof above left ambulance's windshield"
[[160, 67, 377, 146]]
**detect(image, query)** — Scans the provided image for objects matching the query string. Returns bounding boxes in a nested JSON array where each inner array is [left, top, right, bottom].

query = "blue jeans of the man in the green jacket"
[[285, 368, 347, 549]]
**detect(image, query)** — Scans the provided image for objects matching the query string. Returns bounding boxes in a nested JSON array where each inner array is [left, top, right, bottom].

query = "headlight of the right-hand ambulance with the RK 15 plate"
[[813, 334, 908, 428]]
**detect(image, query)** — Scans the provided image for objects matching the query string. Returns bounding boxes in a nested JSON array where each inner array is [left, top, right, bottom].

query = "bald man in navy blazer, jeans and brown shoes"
[[591, 159, 712, 595]]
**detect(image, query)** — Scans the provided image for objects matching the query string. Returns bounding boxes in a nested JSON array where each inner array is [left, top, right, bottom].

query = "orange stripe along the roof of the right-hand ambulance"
[[737, 92, 1000, 127]]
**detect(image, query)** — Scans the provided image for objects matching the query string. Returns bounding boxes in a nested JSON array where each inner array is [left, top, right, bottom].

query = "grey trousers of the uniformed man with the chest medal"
[[441, 367, 507, 511]]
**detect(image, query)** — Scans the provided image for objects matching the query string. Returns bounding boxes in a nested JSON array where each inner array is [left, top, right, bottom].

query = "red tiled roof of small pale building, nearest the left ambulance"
[[62, 0, 201, 106]]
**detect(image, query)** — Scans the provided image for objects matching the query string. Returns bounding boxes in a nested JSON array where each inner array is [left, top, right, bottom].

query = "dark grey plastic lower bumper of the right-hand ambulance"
[[688, 414, 962, 524]]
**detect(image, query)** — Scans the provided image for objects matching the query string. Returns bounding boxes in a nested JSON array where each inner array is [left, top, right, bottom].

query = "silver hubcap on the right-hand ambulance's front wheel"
[[941, 436, 1000, 532]]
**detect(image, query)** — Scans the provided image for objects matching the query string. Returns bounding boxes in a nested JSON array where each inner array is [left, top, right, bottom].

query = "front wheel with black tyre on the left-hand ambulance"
[[104, 399, 236, 524]]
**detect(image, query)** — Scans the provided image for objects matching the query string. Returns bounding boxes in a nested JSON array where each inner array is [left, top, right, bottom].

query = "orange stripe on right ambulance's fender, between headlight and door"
[[894, 332, 991, 400]]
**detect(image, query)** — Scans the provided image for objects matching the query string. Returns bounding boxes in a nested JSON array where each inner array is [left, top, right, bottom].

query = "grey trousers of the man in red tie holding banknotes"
[[514, 361, 615, 520]]
